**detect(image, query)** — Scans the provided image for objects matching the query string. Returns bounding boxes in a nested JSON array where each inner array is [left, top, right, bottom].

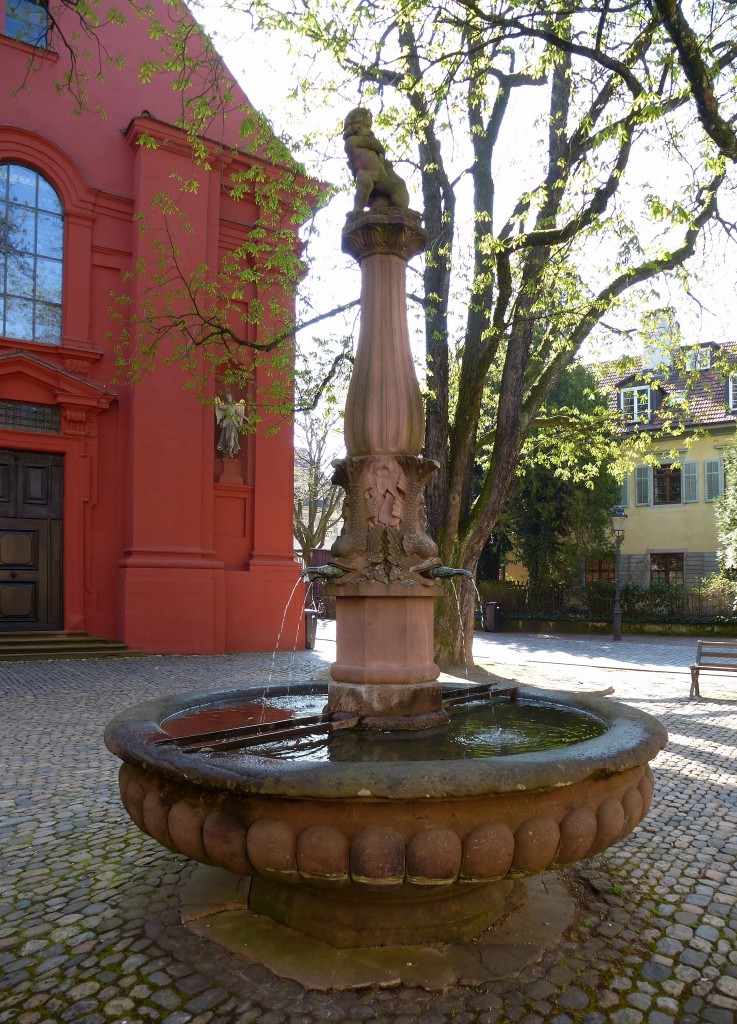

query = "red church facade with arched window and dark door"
[[0, 0, 301, 653]]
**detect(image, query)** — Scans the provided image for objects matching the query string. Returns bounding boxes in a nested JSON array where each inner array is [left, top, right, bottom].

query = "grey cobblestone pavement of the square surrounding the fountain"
[[0, 634, 737, 1024]]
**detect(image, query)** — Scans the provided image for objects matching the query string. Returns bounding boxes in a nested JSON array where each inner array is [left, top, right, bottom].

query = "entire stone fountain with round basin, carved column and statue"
[[105, 109, 667, 948]]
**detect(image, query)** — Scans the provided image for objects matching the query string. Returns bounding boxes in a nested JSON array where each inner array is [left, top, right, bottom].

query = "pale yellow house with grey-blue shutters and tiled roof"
[[605, 342, 737, 587]]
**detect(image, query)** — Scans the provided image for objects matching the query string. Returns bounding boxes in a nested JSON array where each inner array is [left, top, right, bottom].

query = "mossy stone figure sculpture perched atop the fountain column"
[[343, 106, 409, 213]]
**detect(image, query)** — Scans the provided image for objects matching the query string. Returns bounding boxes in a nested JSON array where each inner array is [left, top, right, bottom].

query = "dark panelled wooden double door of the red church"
[[0, 449, 63, 632]]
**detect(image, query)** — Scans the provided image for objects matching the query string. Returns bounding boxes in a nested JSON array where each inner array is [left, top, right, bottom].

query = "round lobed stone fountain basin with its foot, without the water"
[[105, 685, 667, 947]]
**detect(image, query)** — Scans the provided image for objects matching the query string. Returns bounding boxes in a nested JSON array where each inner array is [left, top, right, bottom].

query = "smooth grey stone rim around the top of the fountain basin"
[[104, 683, 667, 801]]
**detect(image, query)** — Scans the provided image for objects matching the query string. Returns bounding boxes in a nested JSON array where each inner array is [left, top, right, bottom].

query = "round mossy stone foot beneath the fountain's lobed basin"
[[249, 876, 525, 949]]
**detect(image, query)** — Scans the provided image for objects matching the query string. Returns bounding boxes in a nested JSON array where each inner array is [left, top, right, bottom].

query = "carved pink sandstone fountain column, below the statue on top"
[[328, 207, 447, 729]]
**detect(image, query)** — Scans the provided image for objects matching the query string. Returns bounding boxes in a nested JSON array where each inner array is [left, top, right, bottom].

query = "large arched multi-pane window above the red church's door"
[[0, 164, 63, 345]]
